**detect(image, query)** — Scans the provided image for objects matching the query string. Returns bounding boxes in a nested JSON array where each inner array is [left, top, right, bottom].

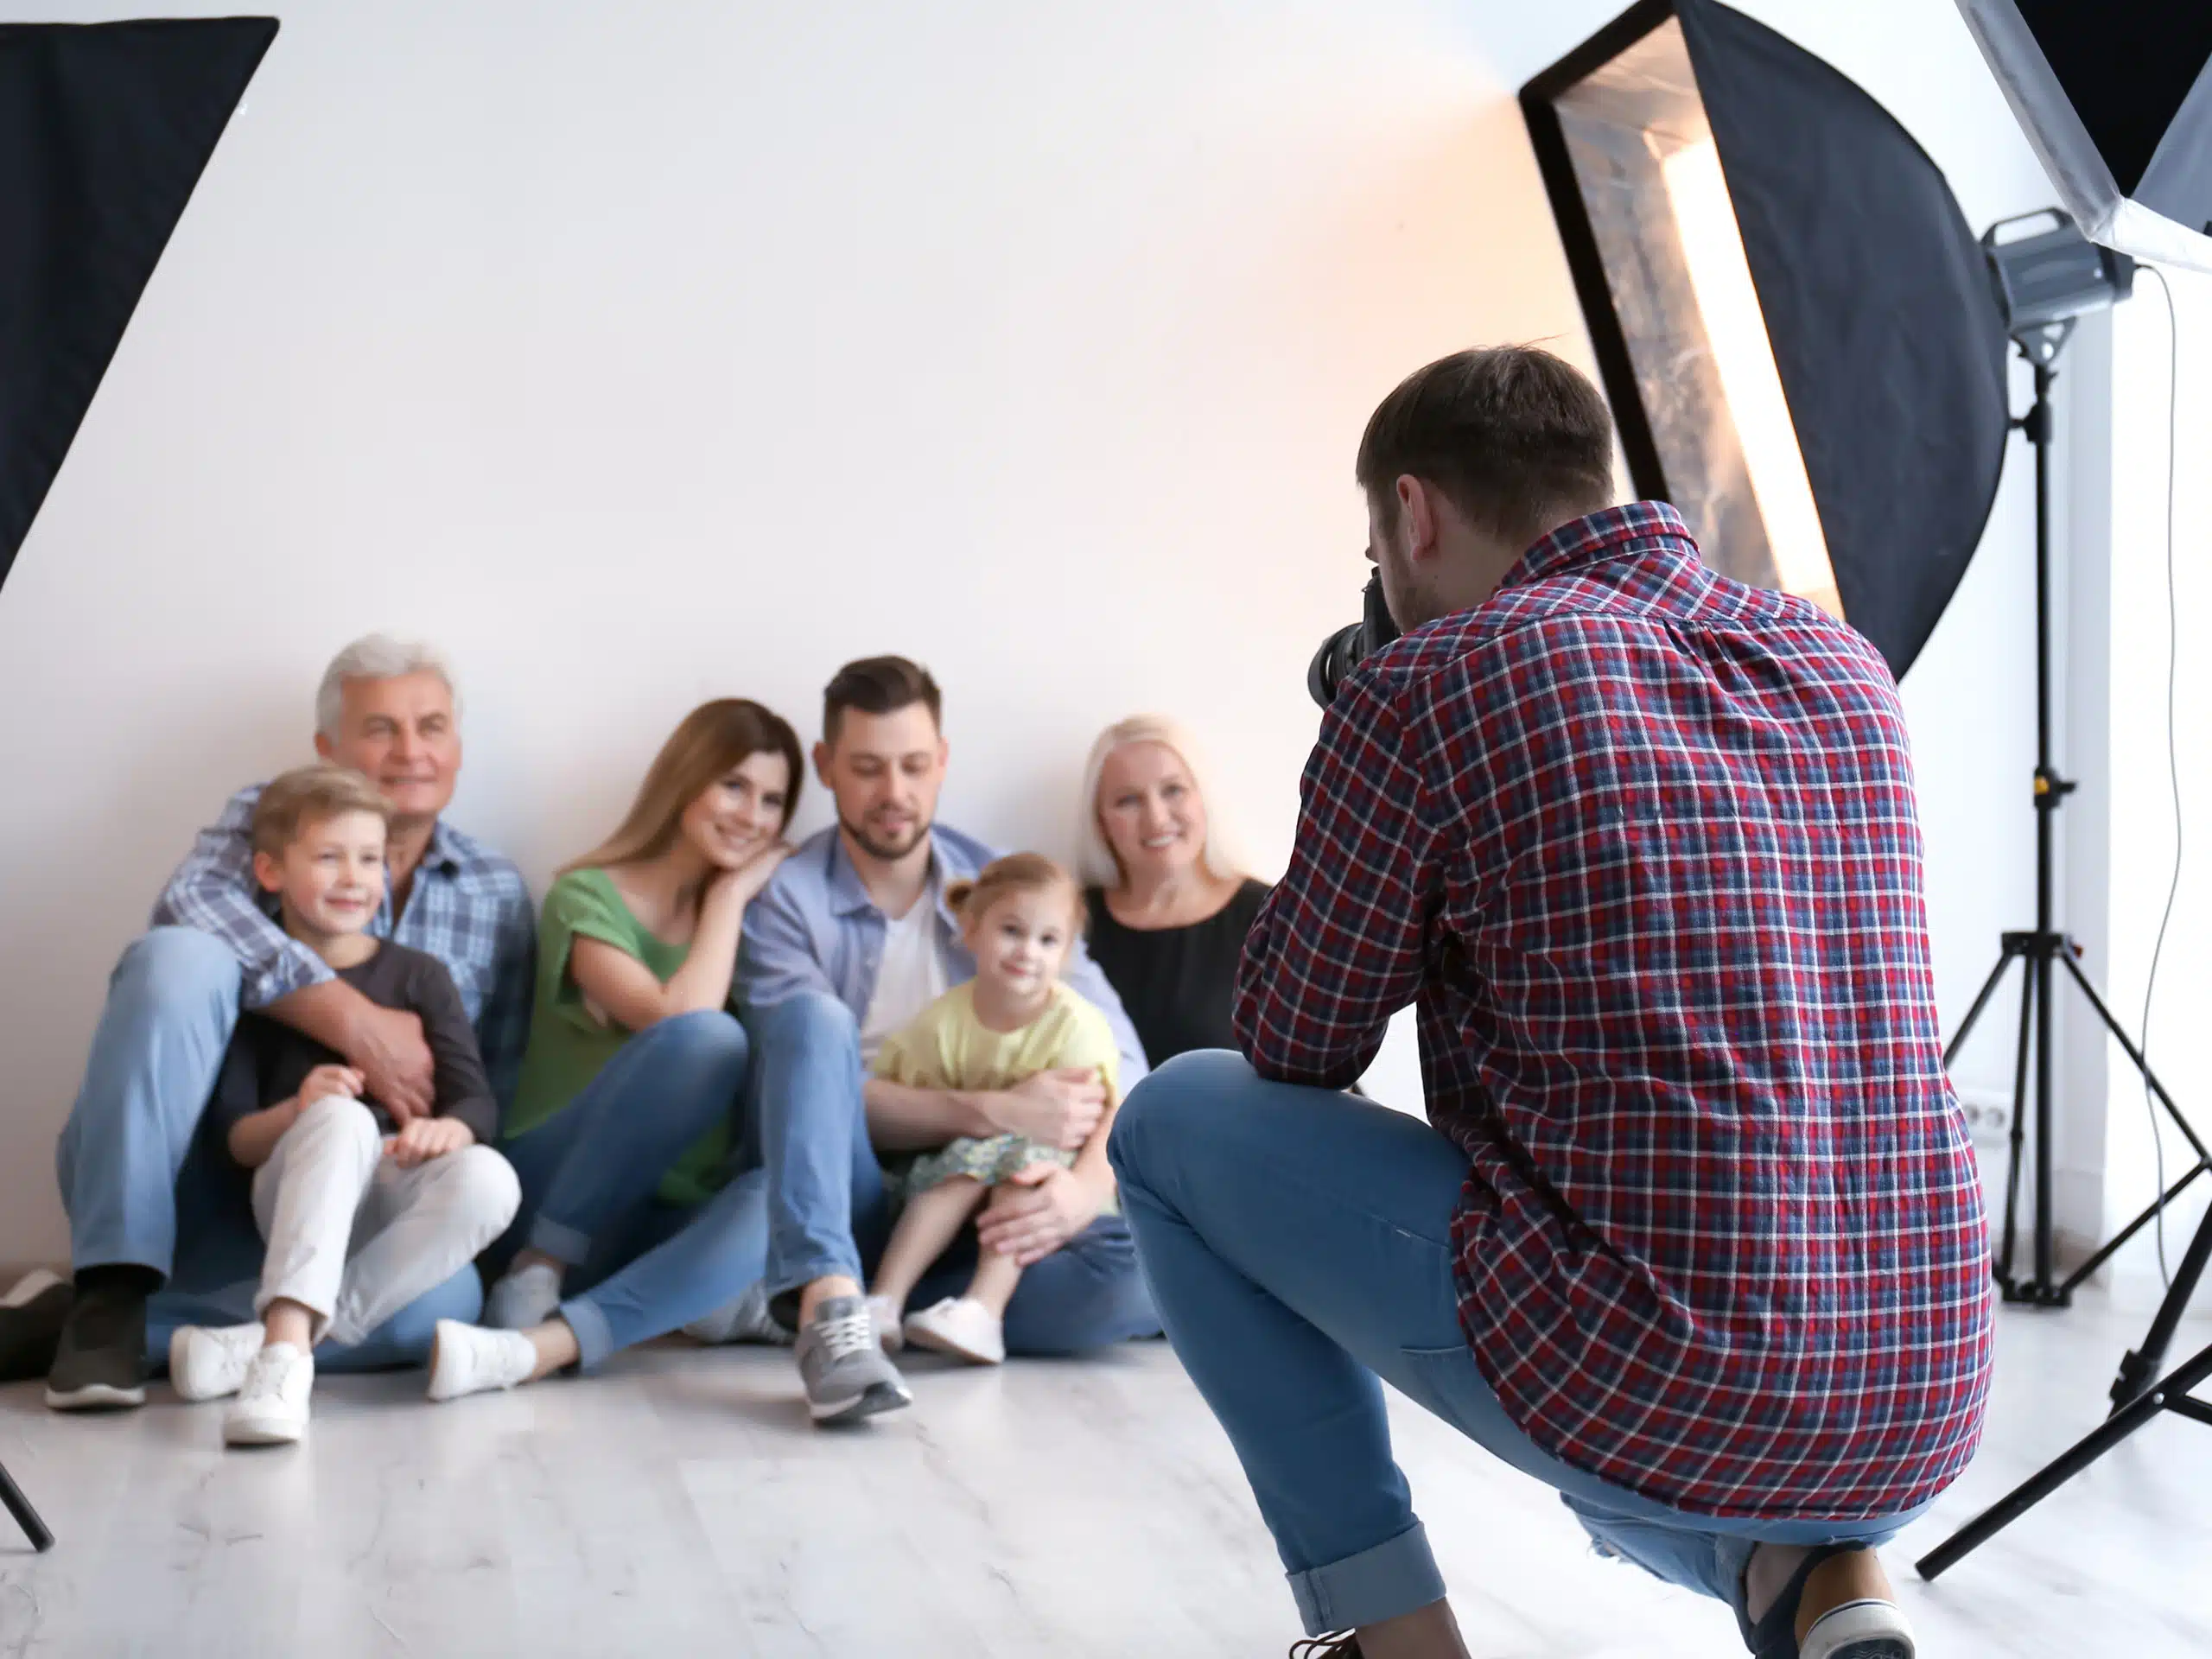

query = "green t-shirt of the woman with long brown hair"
[[506, 869, 730, 1204]]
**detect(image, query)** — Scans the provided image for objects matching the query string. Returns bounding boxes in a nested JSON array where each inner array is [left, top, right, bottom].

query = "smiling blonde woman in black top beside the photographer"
[[1082, 715, 1268, 1066]]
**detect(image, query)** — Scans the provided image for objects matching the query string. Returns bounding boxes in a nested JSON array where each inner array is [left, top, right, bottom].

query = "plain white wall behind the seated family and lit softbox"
[[0, 0, 2049, 1259]]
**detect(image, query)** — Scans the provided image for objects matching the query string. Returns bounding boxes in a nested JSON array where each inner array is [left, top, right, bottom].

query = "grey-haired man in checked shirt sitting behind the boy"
[[0, 635, 533, 1411]]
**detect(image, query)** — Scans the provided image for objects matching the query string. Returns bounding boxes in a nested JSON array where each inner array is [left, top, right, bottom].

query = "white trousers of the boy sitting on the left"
[[254, 1095, 522, 1344]]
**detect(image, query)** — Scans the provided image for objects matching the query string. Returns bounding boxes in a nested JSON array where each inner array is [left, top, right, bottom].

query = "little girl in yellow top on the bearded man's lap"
[[869, 852, 1117, 1365]]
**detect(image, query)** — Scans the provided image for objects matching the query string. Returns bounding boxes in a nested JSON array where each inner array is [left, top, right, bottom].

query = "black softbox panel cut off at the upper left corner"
[[0, 17, 276, 582]]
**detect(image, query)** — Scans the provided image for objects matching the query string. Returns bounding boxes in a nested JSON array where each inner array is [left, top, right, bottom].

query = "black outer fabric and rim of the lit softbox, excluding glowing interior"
[[1522, 0, 2011, 677]]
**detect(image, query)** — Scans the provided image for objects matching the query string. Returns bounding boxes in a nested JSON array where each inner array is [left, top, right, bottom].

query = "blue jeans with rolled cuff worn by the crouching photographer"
[[1110, 1053, 1918, 1635]]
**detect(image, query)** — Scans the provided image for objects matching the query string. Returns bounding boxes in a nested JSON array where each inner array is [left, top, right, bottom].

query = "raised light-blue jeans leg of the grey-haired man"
[[55, 927, 239, 1276]]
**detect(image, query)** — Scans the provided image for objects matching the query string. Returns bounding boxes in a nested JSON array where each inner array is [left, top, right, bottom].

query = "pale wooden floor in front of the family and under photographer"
[[0, 1303, 2212, 1659]]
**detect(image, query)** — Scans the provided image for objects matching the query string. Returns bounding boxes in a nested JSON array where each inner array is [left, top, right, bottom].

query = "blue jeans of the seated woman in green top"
[[493, 1008, 767, 1370]]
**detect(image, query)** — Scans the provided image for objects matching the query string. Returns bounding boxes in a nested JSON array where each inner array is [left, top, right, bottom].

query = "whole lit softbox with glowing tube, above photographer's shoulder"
[[1520, 0, 2011, 677]]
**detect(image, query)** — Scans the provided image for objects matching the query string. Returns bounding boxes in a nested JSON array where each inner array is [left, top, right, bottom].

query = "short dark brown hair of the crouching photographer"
[[1356, 345, 1612, 544]]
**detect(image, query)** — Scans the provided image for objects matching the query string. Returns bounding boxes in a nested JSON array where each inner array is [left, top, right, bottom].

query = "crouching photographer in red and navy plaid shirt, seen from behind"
[[1113, 349, 1991, 1659]]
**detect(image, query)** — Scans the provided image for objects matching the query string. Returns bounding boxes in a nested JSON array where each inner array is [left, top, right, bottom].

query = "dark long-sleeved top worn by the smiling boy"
[[206, 940, 500, 1157]]
